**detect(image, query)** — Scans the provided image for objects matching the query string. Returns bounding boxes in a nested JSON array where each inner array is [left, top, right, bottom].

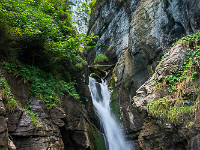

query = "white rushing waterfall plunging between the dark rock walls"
[[89, 77, 133, 150]]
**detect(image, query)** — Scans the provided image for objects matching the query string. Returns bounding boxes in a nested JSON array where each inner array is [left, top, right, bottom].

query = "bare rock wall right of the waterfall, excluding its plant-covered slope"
[[87, 0, 200, 150]]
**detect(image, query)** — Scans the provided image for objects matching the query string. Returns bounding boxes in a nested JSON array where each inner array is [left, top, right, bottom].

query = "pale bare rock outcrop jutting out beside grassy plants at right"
[[133, 43, 188, 110]]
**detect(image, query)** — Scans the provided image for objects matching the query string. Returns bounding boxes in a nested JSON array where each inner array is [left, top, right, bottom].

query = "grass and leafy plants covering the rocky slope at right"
[[147, 31, 200, 124]]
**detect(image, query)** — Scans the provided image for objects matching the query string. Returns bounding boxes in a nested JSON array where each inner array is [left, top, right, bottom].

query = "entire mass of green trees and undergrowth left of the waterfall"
[[0, 0, 99, 108]]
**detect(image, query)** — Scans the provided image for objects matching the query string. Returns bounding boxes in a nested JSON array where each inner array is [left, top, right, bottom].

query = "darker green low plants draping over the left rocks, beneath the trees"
[[2, 62, 79, 109]]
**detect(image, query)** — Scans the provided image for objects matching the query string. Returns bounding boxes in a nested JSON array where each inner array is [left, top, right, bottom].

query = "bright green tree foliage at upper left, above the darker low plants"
[[0, 0, 96, 72]]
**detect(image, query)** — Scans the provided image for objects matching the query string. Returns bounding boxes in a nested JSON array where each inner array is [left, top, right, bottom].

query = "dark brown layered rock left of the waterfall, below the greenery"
[[0, 70, 94, 150]]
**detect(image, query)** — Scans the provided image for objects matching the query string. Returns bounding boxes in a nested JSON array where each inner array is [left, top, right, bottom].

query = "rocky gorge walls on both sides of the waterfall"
[[0, 0, 200, 150]]
